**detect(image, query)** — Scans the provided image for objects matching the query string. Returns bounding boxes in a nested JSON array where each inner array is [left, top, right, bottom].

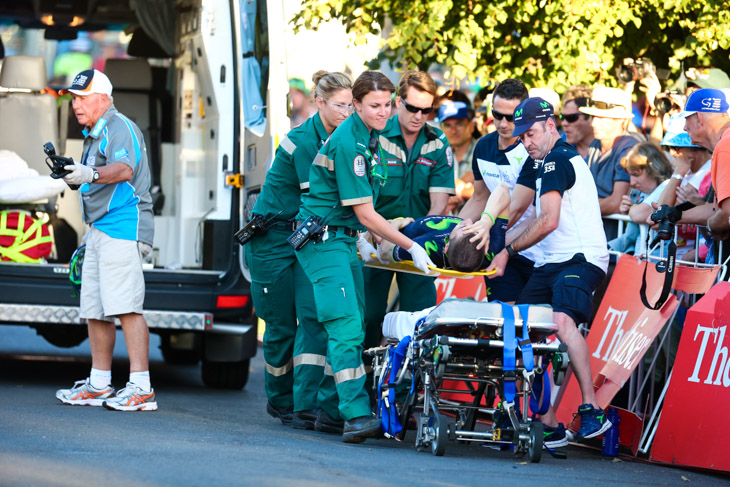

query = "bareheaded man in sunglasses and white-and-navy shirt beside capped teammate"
[[459, 79, 540, 303]]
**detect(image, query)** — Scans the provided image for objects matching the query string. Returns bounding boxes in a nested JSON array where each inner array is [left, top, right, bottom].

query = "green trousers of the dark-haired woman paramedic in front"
[[297, 230, 370, 420]]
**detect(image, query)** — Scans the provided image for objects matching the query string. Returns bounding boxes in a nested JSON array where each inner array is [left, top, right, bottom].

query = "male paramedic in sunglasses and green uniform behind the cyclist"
[[363, 71, 454, 349]]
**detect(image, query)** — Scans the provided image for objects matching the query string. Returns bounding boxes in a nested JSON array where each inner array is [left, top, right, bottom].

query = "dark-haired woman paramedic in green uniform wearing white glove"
[[296, 71, 432, 443]]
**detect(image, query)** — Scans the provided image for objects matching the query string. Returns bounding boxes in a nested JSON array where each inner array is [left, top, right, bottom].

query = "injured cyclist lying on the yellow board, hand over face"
[[358, 184, 510, 272]]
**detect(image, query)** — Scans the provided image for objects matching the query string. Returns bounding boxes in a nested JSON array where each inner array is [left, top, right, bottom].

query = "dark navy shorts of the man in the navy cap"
[[517, 254, 606, 324]]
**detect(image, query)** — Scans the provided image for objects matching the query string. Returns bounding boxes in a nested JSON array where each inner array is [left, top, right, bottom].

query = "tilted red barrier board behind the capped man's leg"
[[556, 255, 677, 429]]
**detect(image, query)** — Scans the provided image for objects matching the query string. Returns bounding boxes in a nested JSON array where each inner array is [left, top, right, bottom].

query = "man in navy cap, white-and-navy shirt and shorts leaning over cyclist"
[[480, 98, 611, 448]]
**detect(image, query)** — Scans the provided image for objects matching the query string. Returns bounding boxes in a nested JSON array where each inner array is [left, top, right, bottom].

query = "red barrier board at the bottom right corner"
[[651, 282, 730, 471]]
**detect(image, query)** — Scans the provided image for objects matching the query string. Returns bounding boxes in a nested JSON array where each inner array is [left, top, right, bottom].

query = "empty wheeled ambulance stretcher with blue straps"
[[365, 299, 567, 462]]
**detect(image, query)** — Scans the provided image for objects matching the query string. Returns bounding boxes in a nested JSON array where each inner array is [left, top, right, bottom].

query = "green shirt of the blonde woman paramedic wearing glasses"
[[253, 113, 329, 221]]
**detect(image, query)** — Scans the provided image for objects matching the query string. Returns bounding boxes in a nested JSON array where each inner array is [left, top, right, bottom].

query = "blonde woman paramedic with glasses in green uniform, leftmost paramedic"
[[246, 71, 352, 429]]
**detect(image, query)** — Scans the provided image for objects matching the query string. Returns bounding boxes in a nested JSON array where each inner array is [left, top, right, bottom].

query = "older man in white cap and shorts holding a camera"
[[56, 69, 157, 411]]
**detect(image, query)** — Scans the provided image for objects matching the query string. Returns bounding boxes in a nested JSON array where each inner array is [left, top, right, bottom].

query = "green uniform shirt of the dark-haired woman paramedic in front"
[[297, 113, 379, 230]]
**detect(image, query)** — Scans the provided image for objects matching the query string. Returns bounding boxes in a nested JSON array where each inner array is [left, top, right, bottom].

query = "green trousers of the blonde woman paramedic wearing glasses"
[[246, 224, 324, 411]]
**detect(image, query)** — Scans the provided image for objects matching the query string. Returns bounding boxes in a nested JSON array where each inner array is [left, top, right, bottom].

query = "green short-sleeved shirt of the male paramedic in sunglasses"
[[375, 115, 455, 218]]
